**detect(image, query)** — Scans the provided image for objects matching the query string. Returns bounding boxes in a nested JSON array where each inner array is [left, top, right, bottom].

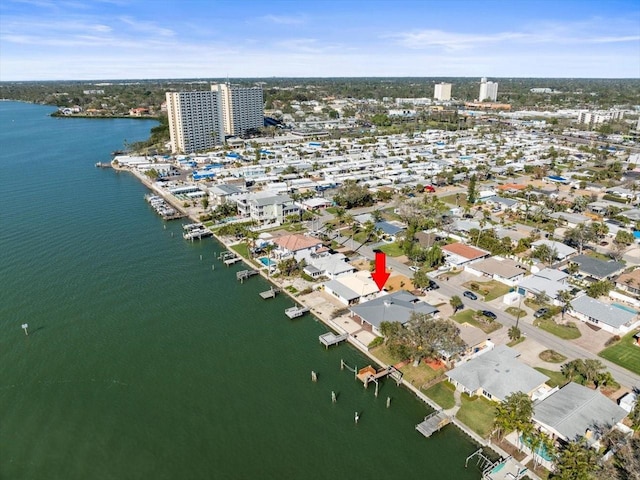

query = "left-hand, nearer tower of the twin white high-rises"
[[166, 91, 225, 153]]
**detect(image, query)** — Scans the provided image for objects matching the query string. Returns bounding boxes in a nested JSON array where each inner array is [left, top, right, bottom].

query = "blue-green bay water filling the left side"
[[0, 102, 480, 480]]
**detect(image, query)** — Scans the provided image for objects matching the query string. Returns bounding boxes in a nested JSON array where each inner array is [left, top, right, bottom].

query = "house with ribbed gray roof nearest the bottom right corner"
[[533, 382, 627, 443]]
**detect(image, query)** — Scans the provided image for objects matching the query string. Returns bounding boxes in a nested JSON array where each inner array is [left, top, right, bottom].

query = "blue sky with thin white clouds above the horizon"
[[0, 0, 640, 81]]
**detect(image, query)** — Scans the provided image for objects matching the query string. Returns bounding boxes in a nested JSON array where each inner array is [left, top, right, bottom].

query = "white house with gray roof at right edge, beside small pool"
[[568, 295, 640, 335]]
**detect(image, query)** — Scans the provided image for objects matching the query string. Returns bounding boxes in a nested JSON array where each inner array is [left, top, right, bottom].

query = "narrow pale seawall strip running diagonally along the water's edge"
[[112, 162, 520, 470]]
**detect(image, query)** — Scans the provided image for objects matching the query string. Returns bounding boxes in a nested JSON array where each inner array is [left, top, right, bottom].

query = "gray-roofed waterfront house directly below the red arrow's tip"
[[349, 290, 438, 335]]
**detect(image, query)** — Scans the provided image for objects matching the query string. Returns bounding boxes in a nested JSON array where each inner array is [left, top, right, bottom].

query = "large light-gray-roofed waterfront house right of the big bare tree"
[[446, 345, 549, 402]]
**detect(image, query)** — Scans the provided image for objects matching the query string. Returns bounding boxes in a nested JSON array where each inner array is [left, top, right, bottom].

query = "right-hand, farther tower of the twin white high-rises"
[[211, 83, 264, 135]]
